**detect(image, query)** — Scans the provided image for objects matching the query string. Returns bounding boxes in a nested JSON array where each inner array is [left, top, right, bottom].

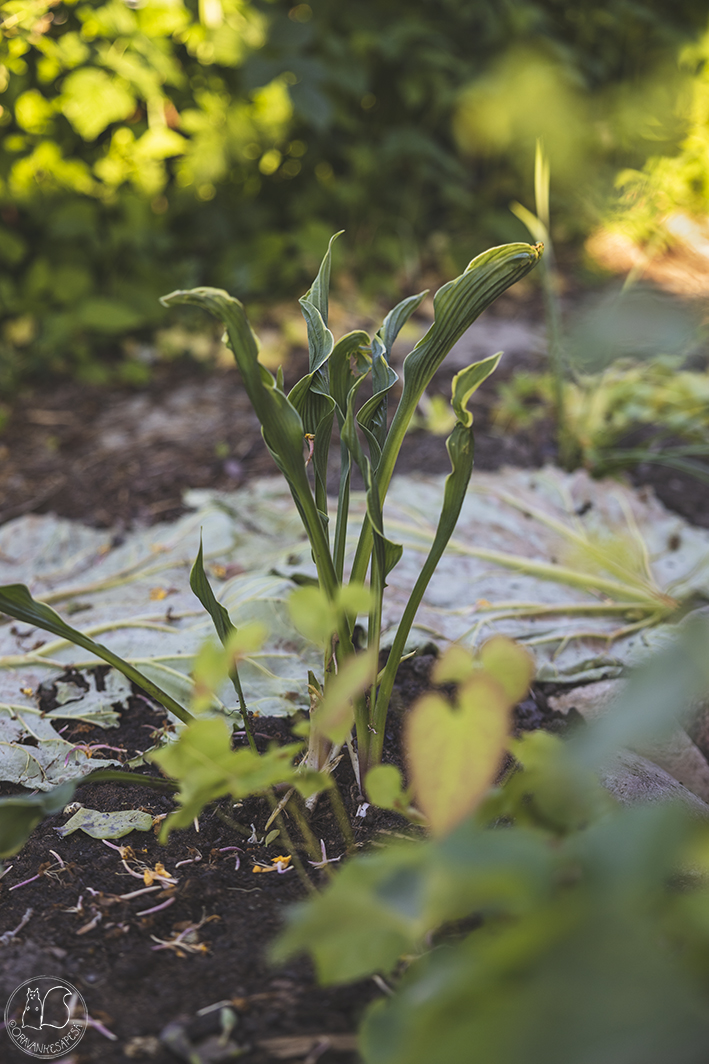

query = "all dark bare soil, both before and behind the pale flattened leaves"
[[0, 295, 709, 1064]]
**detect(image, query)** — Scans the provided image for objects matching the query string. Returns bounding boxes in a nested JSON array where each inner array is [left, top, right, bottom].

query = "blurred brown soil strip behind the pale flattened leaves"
[[0, 299, 709, 532]]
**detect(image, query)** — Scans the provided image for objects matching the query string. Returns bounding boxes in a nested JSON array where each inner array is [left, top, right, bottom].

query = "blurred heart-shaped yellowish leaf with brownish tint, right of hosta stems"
[[405, 671, 511, 835]]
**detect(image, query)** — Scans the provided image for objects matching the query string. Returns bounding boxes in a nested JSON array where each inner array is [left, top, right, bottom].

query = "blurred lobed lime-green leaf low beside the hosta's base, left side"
[[148, 717, 300, 838]]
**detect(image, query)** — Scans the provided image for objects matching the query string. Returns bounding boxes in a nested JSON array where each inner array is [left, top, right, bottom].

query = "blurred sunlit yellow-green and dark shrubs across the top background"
[[0, 0, 704, 387]]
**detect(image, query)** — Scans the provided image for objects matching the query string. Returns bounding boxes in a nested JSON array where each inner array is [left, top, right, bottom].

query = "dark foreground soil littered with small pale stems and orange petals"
[[0, 652, 574, 1064]]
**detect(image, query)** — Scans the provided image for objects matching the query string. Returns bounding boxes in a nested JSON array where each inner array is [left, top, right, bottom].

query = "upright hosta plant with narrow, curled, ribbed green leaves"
[[0, 237, 543, 846]]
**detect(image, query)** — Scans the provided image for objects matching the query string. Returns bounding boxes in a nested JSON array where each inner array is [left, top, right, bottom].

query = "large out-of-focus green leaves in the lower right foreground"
[[273, 620, 709, 1064]]
